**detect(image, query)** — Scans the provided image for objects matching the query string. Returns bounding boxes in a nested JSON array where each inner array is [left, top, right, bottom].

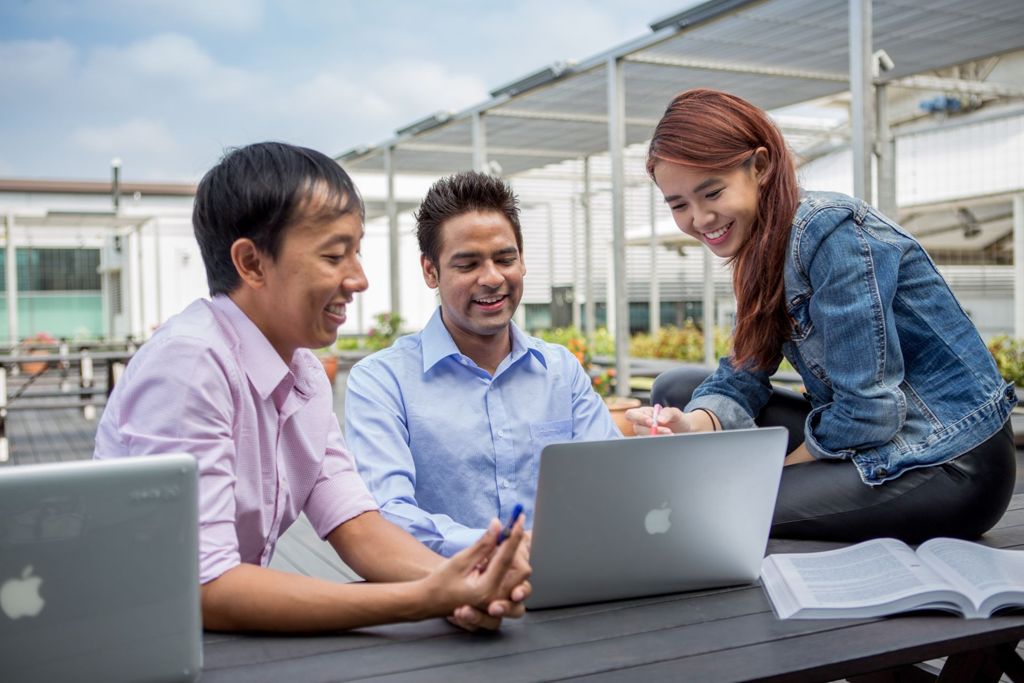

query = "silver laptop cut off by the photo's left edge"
[[0, 455, 202, 683]]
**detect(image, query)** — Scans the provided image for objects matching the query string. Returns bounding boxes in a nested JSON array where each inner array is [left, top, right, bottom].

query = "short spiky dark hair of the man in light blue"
[[416, 171, 522, 265]]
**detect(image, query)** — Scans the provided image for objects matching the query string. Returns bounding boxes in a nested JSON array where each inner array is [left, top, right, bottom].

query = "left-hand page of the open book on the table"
[[771, 539, 949, 608]]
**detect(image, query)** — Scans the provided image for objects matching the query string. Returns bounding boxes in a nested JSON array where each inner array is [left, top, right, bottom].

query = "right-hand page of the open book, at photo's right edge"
[[918, 539, 1024, 605]]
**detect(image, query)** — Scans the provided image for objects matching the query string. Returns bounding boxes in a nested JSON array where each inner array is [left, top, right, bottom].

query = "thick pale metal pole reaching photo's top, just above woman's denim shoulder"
[[849, 0, 874, 204]]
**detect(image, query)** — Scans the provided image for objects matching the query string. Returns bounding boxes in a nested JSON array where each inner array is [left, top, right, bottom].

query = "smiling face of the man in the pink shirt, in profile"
[[239, 205, 367, 362]]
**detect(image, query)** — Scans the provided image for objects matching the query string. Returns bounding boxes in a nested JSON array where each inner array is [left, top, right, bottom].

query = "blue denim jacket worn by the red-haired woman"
[[686, 191, 1017, 484]]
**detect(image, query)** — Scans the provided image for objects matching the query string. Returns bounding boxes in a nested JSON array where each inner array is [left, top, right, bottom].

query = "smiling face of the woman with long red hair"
[[654, 148, 763, 258]]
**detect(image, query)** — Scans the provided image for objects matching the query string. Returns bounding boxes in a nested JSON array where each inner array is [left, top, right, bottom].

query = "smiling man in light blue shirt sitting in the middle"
[[345, 172, 622, 555]]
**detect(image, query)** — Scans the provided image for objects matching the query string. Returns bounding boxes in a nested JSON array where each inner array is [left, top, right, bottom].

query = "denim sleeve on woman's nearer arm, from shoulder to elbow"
[[801, 217, 906, 459]]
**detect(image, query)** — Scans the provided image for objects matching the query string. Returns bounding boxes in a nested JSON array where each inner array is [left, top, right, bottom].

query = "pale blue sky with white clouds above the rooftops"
[[0, 0, 695, 182]]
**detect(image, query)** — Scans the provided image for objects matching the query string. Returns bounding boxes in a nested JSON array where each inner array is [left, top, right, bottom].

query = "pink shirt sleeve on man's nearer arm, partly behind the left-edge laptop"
[[107, 337, 241, 584]]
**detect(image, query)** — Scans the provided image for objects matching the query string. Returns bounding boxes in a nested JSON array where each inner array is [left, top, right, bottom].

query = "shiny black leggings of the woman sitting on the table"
[[651, 368, 1017, 543]]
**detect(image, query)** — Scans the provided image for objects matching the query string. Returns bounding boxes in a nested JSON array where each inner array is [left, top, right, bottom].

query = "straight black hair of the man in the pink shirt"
[[193, 142, 365, 296]]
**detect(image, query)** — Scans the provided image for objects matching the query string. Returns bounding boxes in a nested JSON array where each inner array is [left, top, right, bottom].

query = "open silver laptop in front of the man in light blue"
[[526, 427, 787, 608]]
